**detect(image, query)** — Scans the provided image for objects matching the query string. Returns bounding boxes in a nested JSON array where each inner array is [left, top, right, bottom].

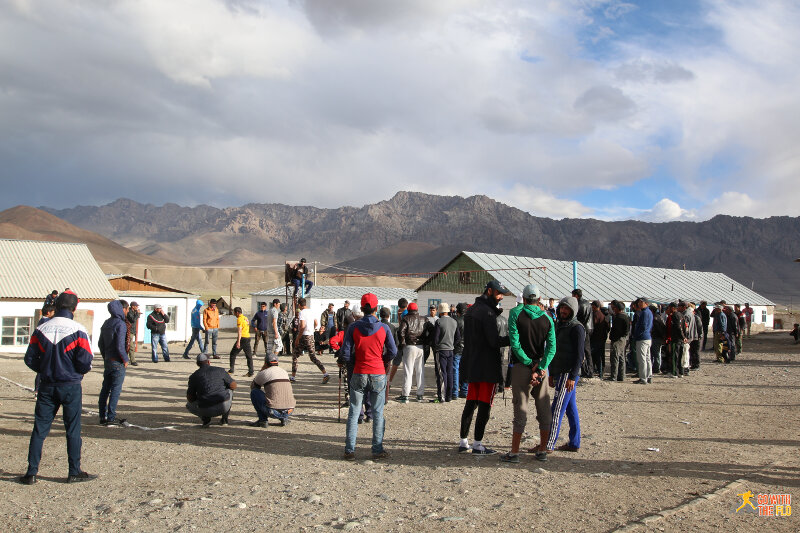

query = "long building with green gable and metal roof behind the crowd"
[[417, 252, 775, 330]]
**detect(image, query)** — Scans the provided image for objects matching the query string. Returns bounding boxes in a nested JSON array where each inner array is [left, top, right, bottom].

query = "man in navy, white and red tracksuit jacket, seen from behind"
[[20, 291, 97, 485]]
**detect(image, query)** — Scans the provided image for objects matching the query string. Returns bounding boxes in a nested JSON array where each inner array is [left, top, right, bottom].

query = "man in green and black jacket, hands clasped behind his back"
[[500, 285, 556, 463]]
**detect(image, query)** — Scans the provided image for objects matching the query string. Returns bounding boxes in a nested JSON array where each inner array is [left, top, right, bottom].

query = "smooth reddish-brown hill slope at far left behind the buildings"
[[0, 206, 177, 264]]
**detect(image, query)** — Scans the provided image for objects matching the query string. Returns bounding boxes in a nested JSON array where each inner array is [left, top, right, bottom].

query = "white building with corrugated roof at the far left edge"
[[0, 239, 117, 353]]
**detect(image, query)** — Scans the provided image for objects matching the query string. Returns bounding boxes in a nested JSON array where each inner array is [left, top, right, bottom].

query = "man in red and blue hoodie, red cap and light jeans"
[[341, 293, 397, 461]]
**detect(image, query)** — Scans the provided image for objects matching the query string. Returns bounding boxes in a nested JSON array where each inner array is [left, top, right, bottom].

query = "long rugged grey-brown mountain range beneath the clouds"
[[43, 192, 800, 303]]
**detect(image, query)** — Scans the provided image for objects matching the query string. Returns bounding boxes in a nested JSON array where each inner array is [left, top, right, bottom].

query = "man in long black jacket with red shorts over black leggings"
[[458, 280, 512, 455]]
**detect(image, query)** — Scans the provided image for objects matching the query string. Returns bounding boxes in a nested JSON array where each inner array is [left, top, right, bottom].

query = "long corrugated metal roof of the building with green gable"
[[418, 252, 775, 305]]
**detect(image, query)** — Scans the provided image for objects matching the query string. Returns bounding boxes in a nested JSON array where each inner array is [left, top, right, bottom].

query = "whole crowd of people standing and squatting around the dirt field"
[[20, 280, 764, 484]]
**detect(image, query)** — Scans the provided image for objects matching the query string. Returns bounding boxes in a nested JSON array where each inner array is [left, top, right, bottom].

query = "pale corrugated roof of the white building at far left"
[[0, 239, 117, 300]]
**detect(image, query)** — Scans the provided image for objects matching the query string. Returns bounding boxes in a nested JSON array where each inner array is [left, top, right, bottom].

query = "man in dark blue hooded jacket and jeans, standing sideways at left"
[[97, 300, 130, 426]]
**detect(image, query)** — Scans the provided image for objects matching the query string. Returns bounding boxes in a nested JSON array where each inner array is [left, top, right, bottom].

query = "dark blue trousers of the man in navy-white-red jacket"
[[26, 383, 83, 476]]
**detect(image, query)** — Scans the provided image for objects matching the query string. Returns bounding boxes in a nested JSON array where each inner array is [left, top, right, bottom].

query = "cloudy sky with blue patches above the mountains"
[[0, 0, 800, 222]]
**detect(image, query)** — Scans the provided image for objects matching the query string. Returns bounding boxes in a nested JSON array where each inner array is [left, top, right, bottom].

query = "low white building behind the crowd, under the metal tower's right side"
[[250, 285, 417, 323]]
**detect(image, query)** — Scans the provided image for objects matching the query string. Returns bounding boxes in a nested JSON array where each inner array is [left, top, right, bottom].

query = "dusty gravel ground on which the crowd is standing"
[[0, 333, 800, 533]]
